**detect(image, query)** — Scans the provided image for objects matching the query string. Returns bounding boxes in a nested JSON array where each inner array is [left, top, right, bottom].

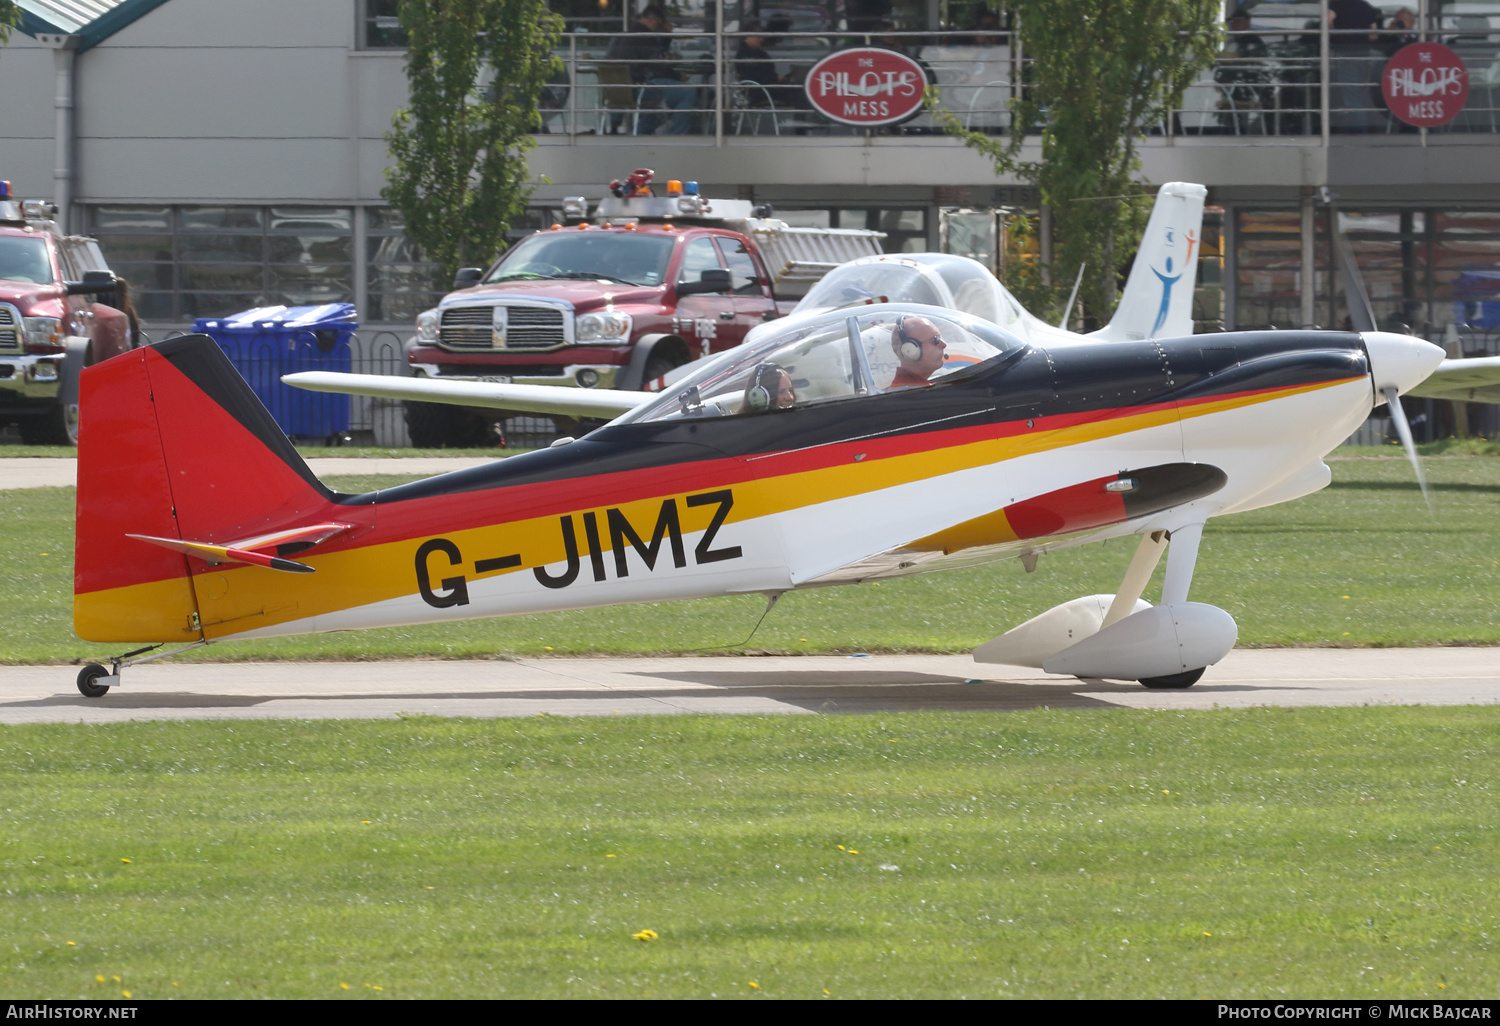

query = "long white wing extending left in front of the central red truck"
[[282, 371, 657, 420]]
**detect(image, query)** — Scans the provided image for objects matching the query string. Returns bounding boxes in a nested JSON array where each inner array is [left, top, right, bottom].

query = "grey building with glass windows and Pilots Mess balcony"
[[0, 0, 1500, 434]]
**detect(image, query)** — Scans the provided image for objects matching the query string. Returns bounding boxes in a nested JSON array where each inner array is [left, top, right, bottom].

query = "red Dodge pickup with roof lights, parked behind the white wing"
[[407, 173, 882, 446]]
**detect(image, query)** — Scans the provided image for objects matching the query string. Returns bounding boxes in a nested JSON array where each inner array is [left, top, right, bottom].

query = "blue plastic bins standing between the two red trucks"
[[192, 303, 360, 440]]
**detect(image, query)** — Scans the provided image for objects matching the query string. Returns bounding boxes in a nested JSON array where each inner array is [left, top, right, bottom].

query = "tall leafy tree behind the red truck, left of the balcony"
[[381, 0, 563, 278]]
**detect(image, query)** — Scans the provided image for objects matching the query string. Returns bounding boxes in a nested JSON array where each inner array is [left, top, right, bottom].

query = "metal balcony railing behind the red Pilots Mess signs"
[[542, 30, 1500, 143]]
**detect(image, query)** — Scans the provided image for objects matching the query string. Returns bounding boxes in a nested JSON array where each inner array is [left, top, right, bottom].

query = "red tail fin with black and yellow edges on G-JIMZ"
[[74, 335, 336, 644]]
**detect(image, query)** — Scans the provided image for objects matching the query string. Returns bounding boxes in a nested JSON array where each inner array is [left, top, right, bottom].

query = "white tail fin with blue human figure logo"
[[1089, 182, 1208, 342]]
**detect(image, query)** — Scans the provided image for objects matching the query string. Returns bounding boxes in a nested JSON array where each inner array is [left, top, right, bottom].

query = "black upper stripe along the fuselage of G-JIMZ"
[[338, 332, 1367, 503]]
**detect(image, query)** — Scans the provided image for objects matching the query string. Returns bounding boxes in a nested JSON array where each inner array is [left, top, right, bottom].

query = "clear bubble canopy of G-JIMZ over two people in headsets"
[[615, 303, 1026, 425]]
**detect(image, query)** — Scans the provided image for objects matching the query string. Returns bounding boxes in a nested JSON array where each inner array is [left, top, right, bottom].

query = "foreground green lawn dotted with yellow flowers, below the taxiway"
[[0, 708, 1500, 999]]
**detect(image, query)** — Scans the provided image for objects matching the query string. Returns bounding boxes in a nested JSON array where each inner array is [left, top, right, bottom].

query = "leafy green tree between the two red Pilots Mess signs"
[[927, 0, 1223, 321]]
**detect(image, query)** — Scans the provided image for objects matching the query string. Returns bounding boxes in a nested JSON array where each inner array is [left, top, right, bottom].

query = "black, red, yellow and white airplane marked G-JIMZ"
[[75, 273, 1443, 696]]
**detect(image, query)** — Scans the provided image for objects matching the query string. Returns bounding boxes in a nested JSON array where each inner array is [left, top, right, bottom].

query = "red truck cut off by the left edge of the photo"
[[0, 182, 138, 446]]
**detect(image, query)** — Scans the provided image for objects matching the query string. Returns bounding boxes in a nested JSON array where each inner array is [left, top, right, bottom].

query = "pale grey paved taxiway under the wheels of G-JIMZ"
[[0, 648, 1500, 725]]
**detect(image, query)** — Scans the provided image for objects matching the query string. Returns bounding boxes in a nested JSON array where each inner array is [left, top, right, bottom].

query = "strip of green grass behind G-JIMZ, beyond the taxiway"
[[0, 458, 1500, 663]]
